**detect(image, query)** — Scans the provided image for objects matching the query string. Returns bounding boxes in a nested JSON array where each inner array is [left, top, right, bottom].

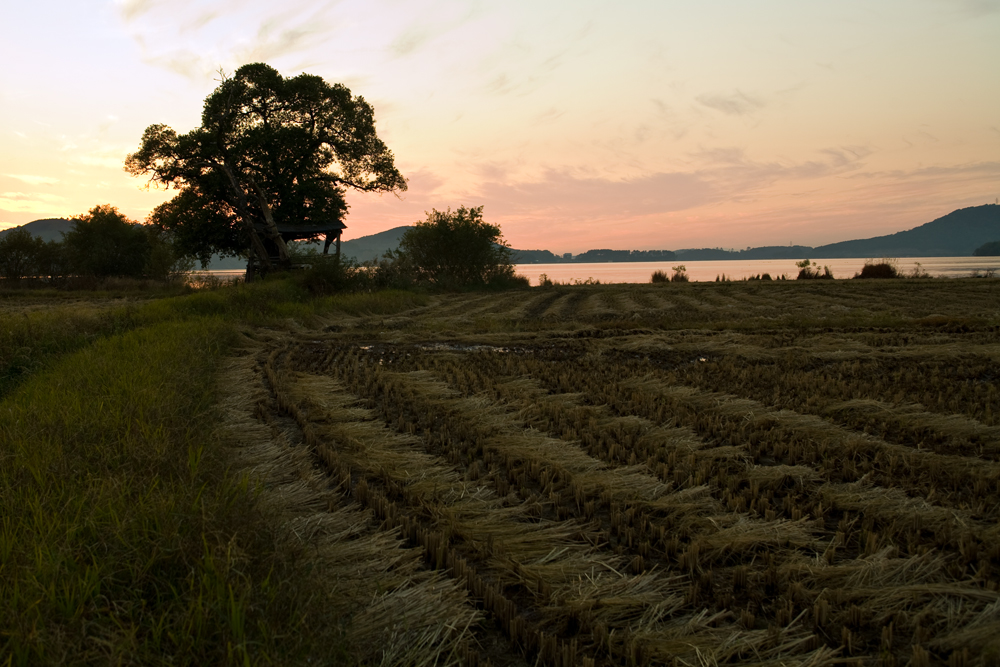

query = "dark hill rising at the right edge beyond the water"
[[812, 204, 1000, 259]]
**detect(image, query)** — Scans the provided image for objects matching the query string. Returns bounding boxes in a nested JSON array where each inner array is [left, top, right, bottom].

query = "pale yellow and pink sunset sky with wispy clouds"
[[0, 0, 1000, 253]]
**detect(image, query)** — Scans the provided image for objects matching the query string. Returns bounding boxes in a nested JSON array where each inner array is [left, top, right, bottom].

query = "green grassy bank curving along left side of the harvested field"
[[0, 282, 423, 665]]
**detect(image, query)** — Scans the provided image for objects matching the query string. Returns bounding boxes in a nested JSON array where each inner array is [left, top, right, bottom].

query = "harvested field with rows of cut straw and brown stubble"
[[227, 279, 1000, 667]]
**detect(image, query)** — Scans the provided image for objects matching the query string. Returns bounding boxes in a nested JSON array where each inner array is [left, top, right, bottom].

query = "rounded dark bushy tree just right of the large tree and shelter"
[[394, 206, 516, 287]]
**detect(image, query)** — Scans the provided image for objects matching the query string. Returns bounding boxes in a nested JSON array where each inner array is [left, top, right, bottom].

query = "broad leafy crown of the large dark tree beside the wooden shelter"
[[125, 63, 406, 267]]
